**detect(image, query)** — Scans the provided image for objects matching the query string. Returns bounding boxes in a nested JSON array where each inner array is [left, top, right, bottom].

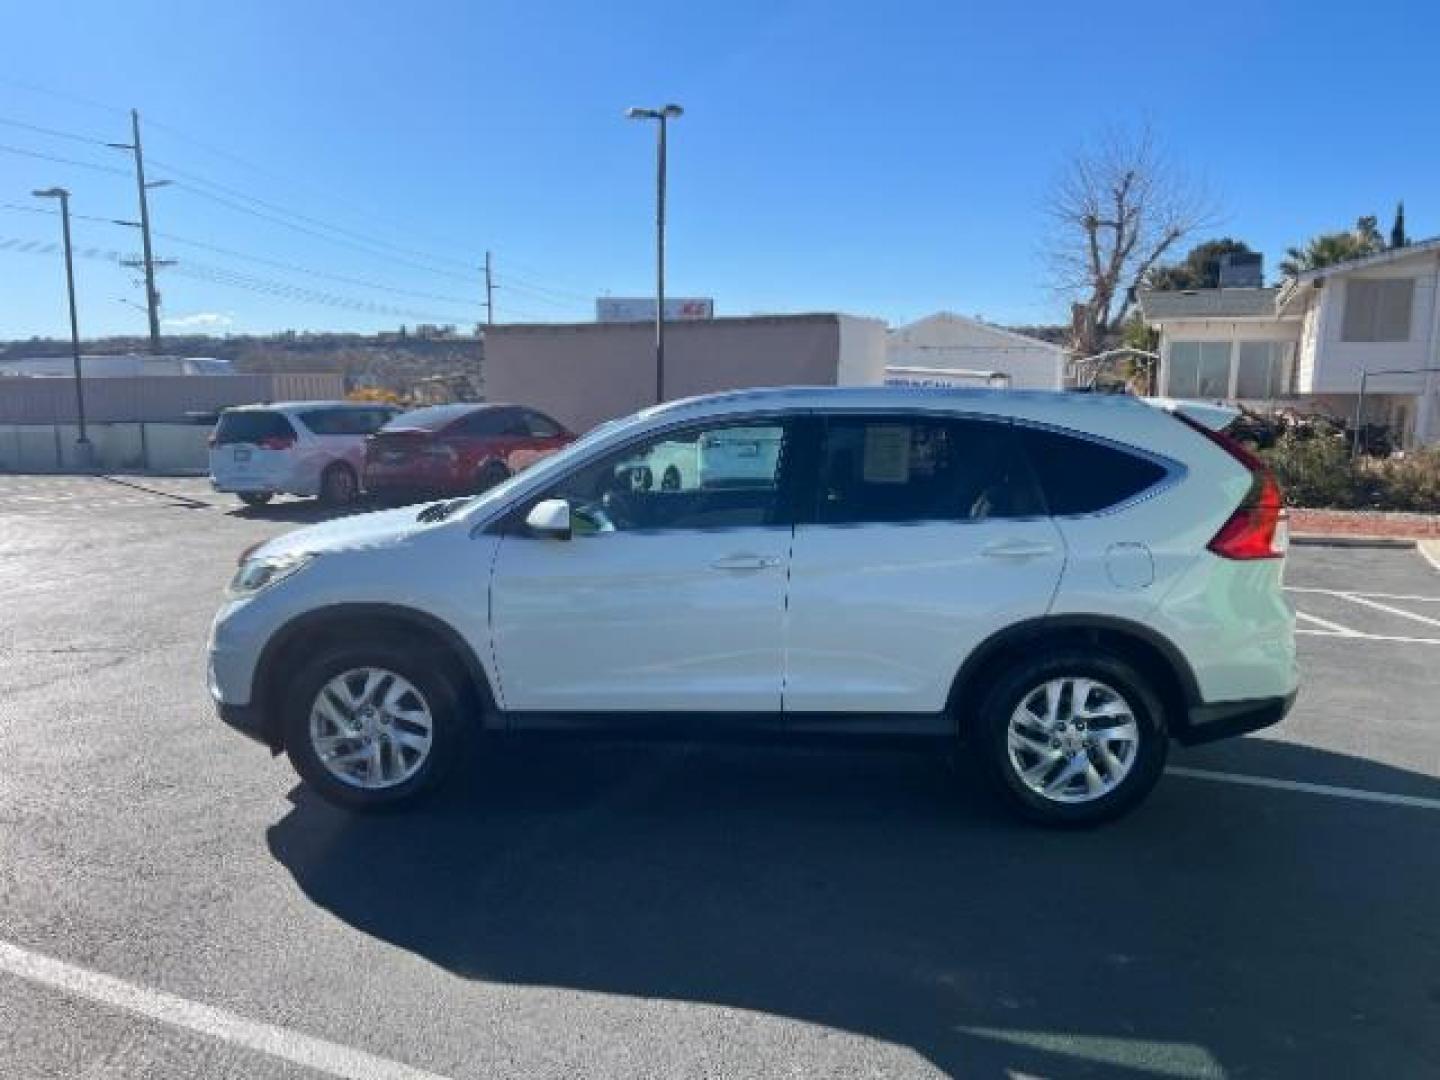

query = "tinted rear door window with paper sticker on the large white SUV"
[[815, 416, 1044, 524]]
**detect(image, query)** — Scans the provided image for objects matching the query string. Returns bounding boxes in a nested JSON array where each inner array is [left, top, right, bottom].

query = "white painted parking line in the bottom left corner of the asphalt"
[[0, 942, 445, 1080]]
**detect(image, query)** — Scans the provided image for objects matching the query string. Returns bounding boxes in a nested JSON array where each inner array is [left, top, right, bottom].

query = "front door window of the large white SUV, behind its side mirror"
[[541, 422, 786, 536]]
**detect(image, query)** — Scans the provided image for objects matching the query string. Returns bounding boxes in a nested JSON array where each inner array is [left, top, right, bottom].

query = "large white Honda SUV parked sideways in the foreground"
[[209, 387, 1296, 824]]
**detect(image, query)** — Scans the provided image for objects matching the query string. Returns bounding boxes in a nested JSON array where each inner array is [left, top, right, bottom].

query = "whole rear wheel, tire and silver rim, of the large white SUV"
[[978, 651, 1169, 825]]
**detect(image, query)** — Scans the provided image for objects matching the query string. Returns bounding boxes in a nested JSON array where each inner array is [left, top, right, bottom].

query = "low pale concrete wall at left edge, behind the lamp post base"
[[0, 423, 212, 472]]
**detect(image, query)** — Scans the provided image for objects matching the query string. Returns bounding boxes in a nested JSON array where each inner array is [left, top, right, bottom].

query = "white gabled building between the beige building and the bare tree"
[[886, 311, 1067, 390]]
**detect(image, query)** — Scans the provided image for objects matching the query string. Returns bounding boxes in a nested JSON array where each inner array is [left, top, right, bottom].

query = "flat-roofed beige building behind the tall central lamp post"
[[485, 314, 886, 431]]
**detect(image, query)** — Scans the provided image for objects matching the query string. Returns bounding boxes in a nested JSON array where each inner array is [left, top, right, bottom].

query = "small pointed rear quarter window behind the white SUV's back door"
[[1015, 425, 1165, 517]]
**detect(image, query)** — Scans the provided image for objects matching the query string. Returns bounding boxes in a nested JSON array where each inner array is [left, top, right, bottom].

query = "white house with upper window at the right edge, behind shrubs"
[[1139, 238, 1440, 446]]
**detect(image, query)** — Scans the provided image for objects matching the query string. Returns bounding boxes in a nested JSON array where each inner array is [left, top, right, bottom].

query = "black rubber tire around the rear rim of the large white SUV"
[[973, 649, 1169, 828]]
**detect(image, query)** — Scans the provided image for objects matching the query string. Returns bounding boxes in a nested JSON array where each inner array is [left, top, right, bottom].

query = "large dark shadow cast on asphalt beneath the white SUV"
[[268, 739, 1440, 1077]]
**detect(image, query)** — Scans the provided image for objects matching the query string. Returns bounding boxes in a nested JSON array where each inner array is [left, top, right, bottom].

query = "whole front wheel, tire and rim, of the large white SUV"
[[282, 642, 468, 811]]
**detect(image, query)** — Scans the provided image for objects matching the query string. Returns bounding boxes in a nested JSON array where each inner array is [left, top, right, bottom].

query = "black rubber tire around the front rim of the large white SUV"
[[281, 641, 472, 811]]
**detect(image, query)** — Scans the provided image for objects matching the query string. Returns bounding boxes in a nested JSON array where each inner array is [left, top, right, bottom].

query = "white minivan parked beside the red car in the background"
[[210, 402, 400, 507]]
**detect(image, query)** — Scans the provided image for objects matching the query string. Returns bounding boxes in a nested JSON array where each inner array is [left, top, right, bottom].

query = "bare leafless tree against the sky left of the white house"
[[1045, 128, 1214, 357]]
